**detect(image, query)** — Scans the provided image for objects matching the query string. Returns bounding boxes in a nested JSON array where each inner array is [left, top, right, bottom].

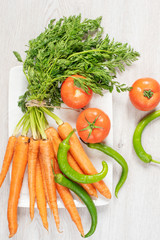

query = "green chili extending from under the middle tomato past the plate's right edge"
[[86, 143, 128, 198]]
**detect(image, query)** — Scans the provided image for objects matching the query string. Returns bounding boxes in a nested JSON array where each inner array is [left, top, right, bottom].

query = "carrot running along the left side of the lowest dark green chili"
[[54, 160, 84, 236]]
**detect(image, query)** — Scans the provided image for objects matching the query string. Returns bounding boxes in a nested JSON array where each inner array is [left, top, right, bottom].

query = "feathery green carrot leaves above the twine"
[[14, 15, 140, 112]]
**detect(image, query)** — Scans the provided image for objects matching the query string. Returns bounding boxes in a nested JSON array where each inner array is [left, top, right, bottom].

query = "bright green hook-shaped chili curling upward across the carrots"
[[57, 130, 108, 183]]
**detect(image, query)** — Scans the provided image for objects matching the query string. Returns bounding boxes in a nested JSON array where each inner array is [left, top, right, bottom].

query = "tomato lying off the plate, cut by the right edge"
[[129, 78, 160, 111]]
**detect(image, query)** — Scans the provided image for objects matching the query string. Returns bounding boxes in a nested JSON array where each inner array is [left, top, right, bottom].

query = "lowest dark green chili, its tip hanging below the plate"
[[51, 161, 97, 238]]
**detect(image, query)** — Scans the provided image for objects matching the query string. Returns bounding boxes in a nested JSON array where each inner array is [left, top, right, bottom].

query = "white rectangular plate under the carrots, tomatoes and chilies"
[[8, 66, 113, 208]]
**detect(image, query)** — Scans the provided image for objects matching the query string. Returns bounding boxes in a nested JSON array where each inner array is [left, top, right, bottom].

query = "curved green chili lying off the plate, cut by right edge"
[[133, 110, 160, 163]]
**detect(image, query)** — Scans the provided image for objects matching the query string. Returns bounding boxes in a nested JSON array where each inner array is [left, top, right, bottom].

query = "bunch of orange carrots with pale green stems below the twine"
[[0, 107, 111, 237]]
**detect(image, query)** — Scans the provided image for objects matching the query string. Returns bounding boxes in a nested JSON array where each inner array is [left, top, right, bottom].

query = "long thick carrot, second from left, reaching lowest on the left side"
[[7, 136, 29, 237]]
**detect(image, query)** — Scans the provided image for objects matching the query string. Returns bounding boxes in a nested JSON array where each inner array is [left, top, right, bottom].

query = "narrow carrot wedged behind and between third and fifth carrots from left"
[[36, 160, 48, 230]]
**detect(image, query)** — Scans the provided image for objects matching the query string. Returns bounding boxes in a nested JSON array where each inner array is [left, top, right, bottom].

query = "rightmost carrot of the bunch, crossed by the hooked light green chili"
[[58, 123, 111, 198]]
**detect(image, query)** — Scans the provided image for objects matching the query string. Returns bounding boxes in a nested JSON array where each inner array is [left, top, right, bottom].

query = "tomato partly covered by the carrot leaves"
[[61, 75, 93, 109]]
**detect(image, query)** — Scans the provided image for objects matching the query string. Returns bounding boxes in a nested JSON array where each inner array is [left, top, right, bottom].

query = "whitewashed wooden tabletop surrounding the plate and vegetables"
[[0, 0, 160, 240]]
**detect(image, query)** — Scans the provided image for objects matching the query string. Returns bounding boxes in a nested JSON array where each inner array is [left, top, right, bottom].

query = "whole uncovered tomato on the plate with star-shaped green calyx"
[[76, 108, 111, 143]]
